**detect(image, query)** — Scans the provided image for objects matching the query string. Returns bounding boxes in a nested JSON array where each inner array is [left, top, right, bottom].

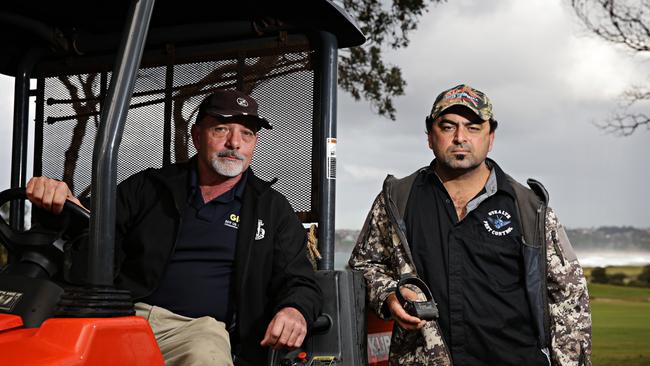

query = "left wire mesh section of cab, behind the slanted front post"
[[41, 68, 164, 196]]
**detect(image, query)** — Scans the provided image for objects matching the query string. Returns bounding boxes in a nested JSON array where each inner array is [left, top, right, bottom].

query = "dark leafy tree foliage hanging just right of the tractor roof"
[[339, 0, 444, 120]]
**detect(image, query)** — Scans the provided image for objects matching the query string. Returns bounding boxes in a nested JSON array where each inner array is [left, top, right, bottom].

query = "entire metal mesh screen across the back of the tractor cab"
[[35, 45, 315, 217]]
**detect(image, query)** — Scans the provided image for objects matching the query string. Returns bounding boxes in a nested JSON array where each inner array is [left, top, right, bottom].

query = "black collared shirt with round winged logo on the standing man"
[[405, 160, 547, 366]]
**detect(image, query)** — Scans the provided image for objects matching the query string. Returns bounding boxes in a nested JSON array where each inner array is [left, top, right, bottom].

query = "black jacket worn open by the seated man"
[[115, 162, 322, 365]]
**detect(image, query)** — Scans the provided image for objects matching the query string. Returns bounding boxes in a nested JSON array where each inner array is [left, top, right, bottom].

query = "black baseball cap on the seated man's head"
[[196, 89, 273, 130]]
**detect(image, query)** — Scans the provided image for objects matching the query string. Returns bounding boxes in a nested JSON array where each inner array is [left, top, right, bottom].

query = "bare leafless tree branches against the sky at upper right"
[[570, 0, 650, 136]]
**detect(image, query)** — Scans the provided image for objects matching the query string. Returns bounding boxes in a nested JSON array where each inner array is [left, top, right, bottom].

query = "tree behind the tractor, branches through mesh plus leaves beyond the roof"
[[40, 0, 445, 193]]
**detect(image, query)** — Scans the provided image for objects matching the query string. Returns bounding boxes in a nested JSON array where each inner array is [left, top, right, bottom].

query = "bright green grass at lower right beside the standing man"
[[589, 278, 650, 366]]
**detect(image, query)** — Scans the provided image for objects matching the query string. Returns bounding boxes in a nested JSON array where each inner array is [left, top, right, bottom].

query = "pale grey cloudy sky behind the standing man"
[[0, 0, 650, 229]]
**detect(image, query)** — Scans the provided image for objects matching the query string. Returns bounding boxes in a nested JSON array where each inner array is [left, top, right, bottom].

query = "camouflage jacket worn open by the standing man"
[[349, 172, 591, 366]]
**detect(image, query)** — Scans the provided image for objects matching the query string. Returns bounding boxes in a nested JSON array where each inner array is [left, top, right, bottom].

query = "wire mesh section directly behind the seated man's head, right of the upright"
[[172, 53, 314, 212]]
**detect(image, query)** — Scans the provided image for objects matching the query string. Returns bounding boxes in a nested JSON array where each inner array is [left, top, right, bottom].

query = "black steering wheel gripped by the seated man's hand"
[[0, 188, 90, 276]]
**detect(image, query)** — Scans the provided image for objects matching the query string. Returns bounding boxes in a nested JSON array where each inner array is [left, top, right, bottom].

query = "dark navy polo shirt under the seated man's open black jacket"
[[142, 166, 247, 325]]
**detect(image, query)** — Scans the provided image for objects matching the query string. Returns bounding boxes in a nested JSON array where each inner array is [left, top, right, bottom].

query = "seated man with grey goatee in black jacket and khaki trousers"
[[27, 90, 322, 365]]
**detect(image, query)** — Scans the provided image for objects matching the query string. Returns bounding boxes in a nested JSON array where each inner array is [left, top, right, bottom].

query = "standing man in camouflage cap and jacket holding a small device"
[[349, 85, 591, 366]]
